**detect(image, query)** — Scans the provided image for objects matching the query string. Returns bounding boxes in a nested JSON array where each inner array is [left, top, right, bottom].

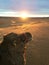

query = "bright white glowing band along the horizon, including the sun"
[[0, 11, 49, 19]]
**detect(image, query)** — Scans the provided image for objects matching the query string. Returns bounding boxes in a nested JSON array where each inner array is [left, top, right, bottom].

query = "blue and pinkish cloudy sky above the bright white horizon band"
[[0, 0, 49, 15]]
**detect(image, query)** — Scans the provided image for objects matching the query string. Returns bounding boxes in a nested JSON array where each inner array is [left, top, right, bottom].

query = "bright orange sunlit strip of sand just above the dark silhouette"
[[0, 23, 48, 35]]
